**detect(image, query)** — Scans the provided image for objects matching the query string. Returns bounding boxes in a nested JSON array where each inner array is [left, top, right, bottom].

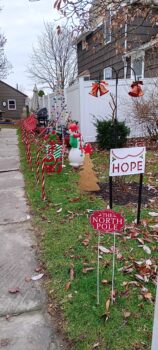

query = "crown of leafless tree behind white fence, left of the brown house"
[[28, 23, 77, 90]]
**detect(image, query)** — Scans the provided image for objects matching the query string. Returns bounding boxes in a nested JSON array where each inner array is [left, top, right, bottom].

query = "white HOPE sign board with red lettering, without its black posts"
[[109, 147, 146, 176]]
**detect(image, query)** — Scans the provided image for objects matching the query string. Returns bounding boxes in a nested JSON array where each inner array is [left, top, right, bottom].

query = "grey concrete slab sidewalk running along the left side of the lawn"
[[0, 129, 63, 350]]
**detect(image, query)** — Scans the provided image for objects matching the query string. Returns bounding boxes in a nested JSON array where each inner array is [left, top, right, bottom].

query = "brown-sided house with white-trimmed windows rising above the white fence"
[[77, 1, 158, 80]]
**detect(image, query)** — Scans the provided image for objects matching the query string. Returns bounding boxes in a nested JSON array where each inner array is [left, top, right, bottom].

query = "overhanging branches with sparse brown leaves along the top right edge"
[[54, 0, 158, 40]]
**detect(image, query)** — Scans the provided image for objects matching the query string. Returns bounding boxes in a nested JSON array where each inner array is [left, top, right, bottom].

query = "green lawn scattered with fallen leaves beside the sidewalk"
[[17, 129, 158, 350]]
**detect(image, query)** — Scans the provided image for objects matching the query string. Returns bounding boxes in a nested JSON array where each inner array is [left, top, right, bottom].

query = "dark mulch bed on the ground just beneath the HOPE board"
[[95, 182, 158, 205]]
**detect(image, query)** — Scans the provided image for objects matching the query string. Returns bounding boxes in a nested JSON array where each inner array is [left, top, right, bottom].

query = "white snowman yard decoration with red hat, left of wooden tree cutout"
[[69, 123, 84, 168]]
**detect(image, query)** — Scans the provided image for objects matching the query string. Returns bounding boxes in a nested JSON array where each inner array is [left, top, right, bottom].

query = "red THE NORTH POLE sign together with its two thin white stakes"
[[90, 209, 124, 305]]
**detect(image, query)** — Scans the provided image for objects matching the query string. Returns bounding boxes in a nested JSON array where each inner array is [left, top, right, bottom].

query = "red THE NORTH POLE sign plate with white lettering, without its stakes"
[[90, 209, 124, 233]]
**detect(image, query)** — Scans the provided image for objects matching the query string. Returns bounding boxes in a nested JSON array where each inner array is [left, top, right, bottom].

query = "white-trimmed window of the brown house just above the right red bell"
[[131, 53, 144, 80]]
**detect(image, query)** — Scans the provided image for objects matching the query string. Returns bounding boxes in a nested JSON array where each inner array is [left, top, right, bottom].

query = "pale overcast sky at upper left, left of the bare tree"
[[0, 0, 58, 96]]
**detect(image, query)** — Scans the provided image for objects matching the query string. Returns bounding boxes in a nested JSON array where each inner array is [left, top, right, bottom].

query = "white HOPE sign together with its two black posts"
[[109, 147, 146, 224]]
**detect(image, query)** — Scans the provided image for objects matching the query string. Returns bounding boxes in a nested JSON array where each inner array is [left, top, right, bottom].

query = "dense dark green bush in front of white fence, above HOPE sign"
[[95, 119, 130, 149]]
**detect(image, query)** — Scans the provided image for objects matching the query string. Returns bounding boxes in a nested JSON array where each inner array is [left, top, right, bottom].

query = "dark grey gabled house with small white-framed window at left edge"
[[0, 81, 28, 119]]
